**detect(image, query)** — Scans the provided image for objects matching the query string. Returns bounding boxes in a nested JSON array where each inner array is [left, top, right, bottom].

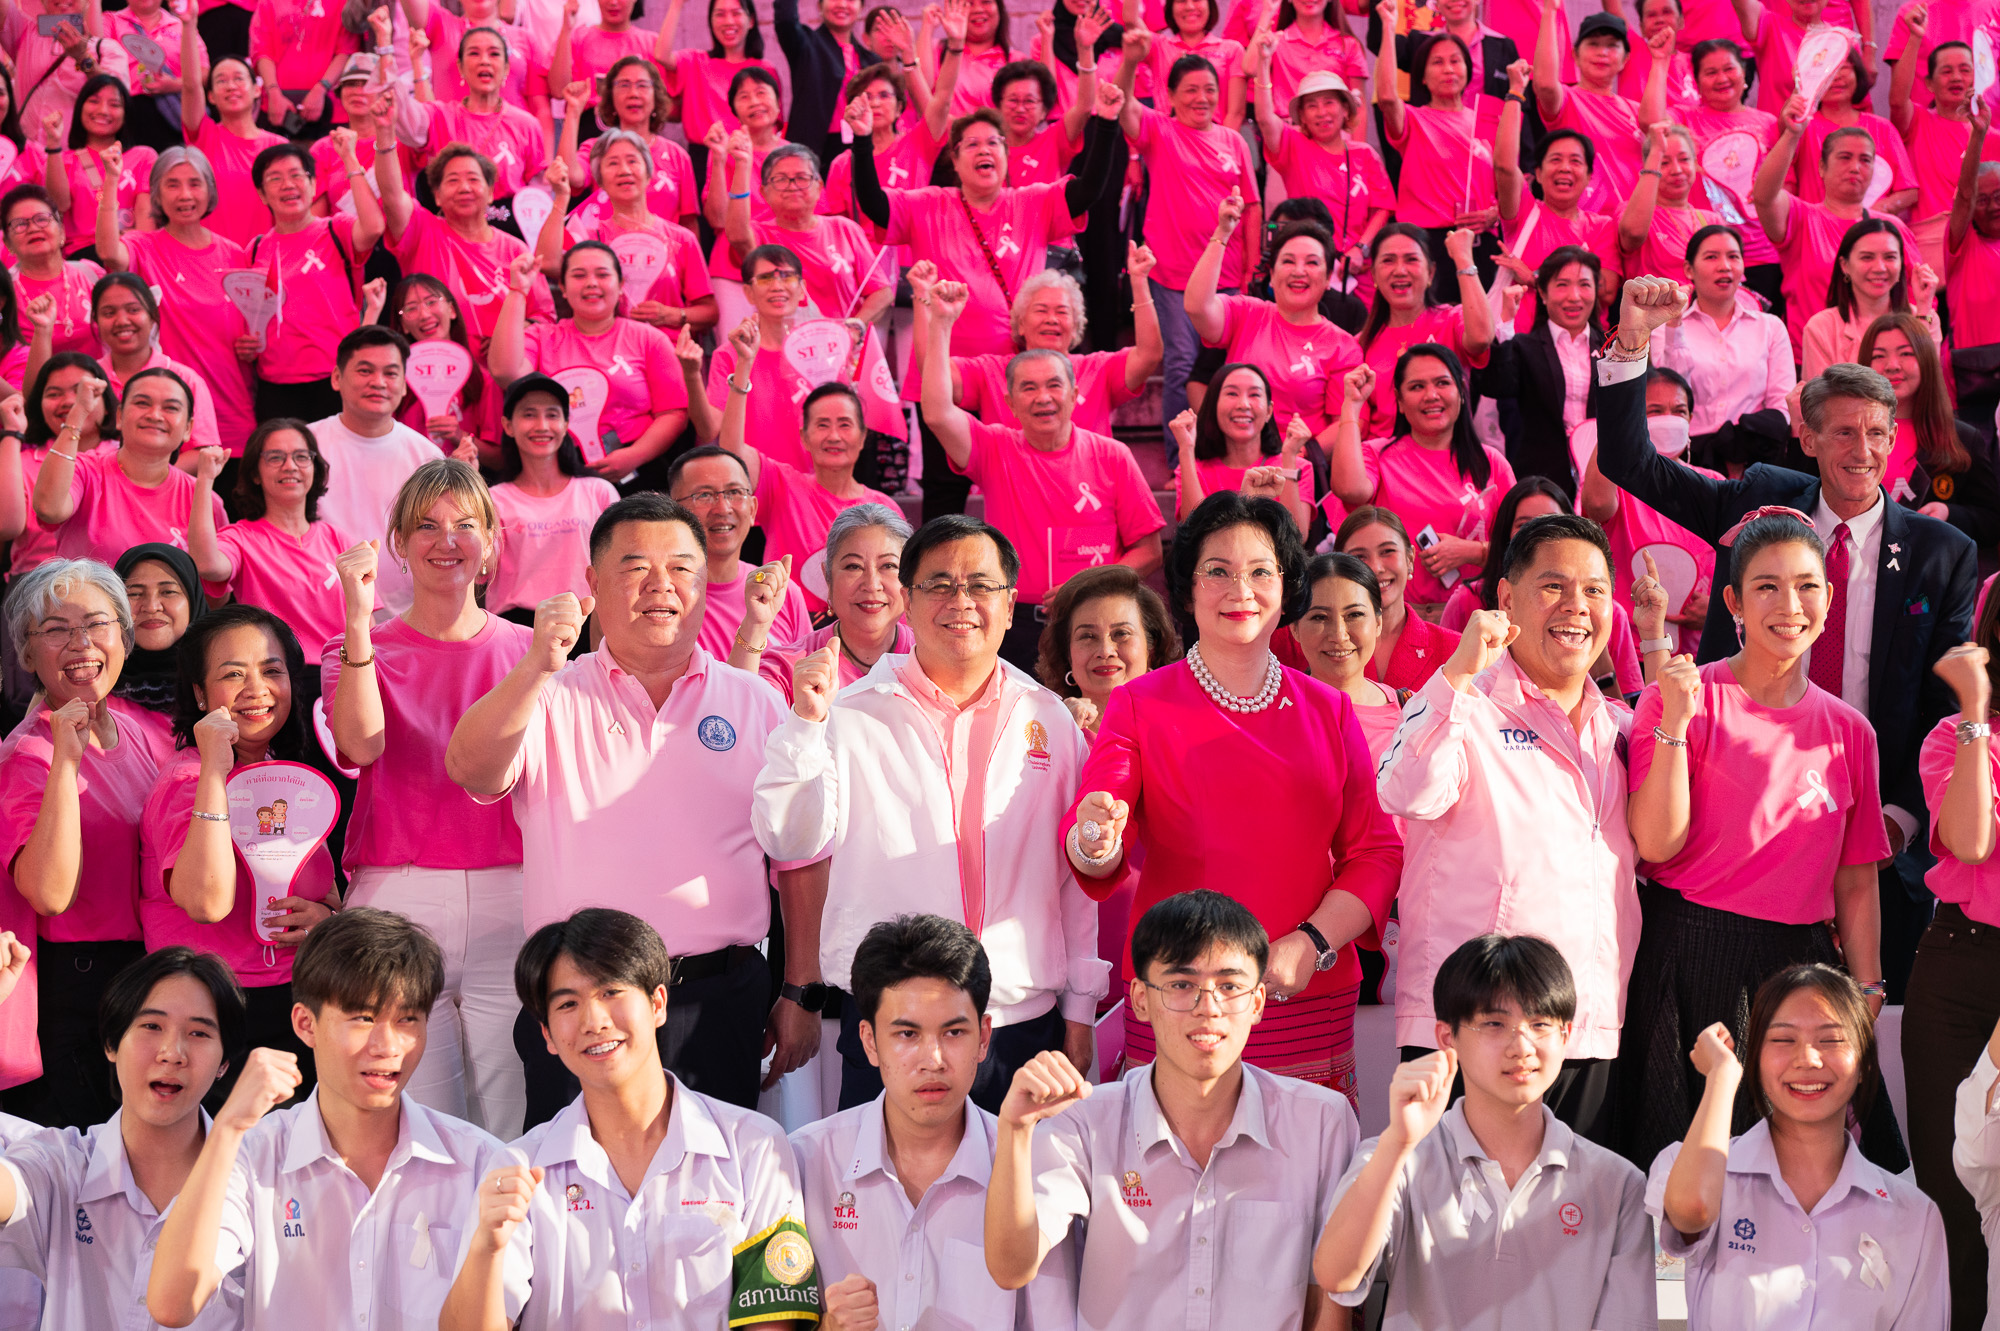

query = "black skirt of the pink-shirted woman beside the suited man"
[[1618, 883, 1910, 1173]]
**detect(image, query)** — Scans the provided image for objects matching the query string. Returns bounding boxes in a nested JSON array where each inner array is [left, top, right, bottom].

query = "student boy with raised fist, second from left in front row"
[[146, 907, 524, 1331]]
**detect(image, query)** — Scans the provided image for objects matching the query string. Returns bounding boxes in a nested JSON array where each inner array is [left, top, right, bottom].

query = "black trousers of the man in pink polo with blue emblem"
[[514, 939, 772, 1127]]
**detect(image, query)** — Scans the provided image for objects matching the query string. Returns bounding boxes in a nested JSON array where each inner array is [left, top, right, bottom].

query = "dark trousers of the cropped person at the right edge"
[[1902, 901, 2000, 1331]]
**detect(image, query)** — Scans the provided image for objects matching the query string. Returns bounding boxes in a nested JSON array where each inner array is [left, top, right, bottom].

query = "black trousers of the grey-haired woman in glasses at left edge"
[[6, 939, 146, 1127]]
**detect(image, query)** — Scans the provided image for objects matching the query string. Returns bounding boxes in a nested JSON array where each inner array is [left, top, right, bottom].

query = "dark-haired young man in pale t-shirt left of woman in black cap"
[[312, 324, 448, 614]]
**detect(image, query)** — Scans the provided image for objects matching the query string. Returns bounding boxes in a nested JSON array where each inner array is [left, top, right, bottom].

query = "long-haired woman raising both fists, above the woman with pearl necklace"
[[1166, 362, 1316, 538]]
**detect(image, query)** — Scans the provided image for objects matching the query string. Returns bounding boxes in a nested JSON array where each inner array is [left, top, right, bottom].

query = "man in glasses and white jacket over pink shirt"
[[752, 516, 1110, 1111]]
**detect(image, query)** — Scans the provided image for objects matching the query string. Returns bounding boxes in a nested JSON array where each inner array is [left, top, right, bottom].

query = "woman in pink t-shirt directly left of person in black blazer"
[[1356, 222, 1494, 438]]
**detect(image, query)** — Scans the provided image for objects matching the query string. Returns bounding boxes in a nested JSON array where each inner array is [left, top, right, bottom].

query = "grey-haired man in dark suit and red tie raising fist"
[[1598, 278, 1978, 983]]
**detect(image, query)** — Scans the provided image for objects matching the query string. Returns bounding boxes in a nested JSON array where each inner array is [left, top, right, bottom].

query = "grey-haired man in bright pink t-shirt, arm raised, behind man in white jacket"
[[924, 282, 1166, 669]]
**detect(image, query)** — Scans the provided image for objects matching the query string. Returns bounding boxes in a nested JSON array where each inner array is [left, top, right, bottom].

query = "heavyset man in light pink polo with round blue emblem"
[[444, 492, 820, 1127]]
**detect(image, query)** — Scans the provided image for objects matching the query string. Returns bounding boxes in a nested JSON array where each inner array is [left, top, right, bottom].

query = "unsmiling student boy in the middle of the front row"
[[792, 915, 1076, 1331]]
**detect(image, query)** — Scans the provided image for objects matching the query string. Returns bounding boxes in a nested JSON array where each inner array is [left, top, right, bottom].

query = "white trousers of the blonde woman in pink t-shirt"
[[348, 863, 528, 1141]]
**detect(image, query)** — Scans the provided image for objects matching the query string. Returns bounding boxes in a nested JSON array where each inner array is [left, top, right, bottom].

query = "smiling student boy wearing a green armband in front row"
[[438, 907, 820, 1331]]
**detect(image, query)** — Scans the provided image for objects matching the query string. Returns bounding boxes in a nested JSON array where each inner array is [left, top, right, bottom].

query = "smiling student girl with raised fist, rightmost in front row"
[[1646, 963, 1950, 1331]]
